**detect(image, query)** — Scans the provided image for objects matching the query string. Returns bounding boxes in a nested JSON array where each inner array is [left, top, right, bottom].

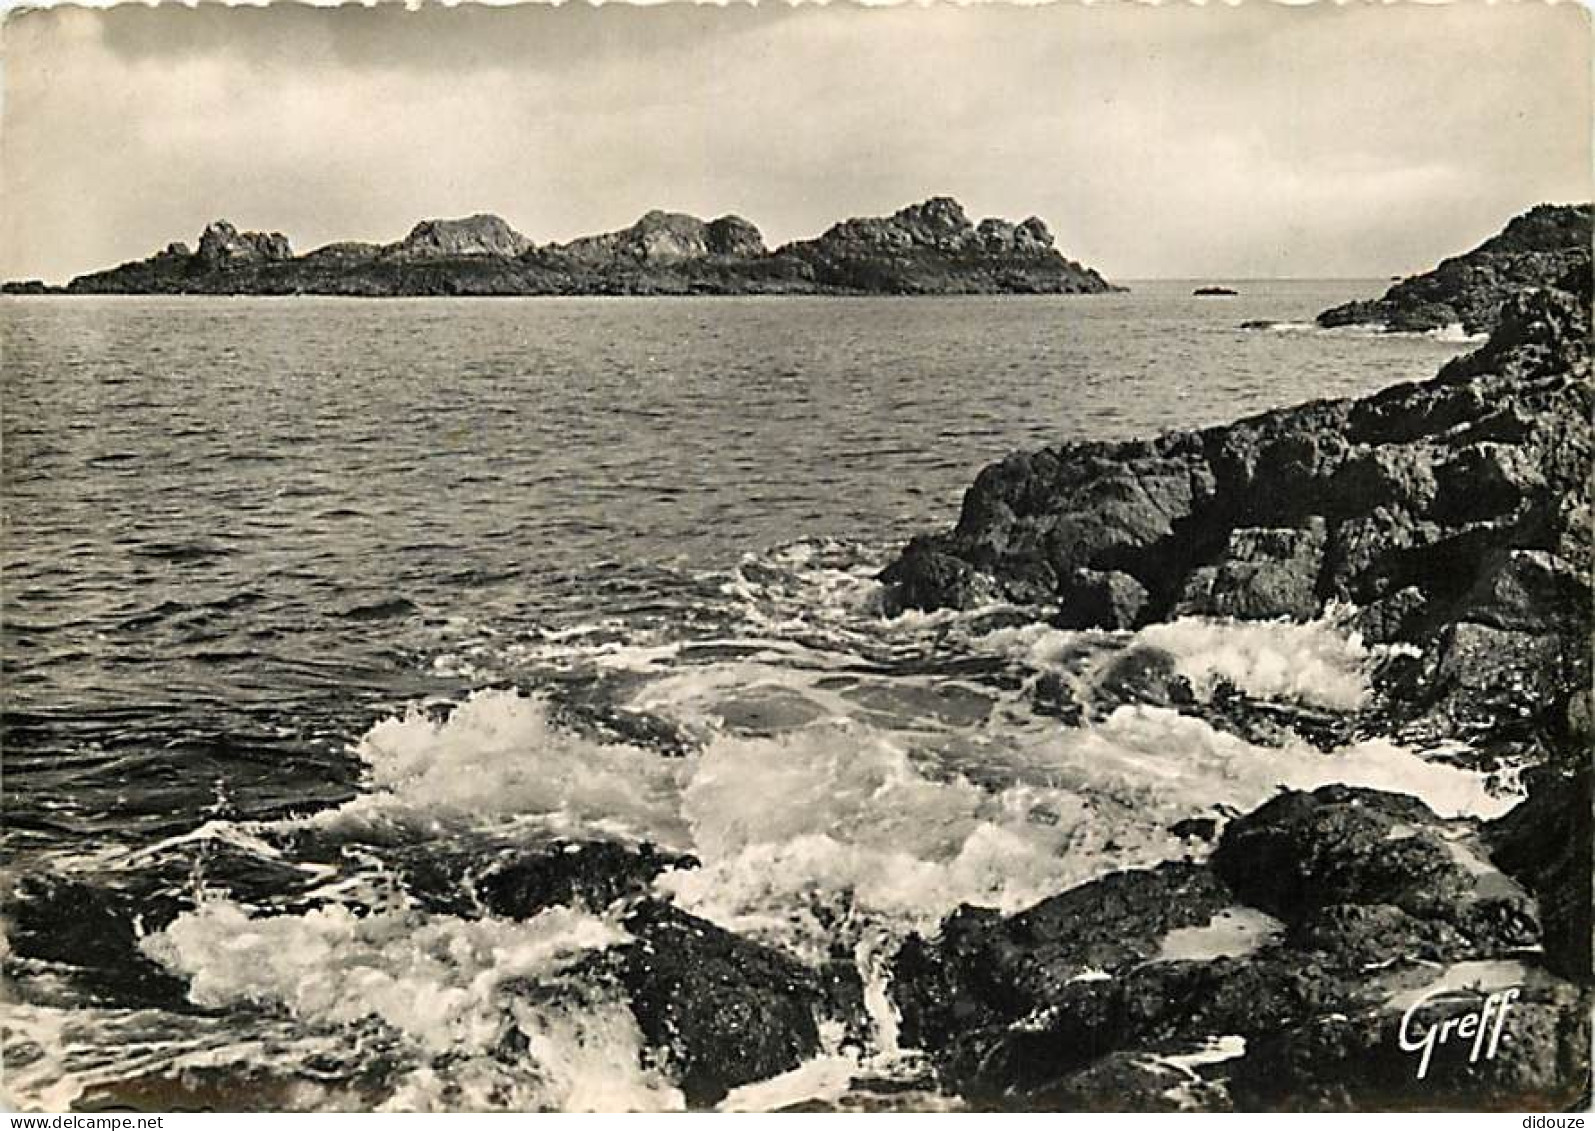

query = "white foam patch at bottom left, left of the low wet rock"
[[142, 901, 681, 1110]]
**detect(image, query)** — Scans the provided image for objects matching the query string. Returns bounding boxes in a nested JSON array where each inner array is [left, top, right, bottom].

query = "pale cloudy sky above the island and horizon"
[[0, 0, 1595, 282]]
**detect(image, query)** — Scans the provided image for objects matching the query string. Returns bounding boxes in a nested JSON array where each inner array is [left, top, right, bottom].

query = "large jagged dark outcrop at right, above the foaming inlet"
[[882, 252, 1595, 749]]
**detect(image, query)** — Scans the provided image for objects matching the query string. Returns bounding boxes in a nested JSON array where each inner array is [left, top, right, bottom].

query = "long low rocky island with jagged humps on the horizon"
[[3, 196, 1121, 297]]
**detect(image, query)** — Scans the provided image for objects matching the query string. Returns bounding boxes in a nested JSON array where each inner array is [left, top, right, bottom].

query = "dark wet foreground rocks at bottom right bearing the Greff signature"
[[893, 786, 1589, 1110]]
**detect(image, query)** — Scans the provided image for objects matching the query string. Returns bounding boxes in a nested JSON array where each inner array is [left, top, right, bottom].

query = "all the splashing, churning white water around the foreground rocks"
[[0, 544, 1514, 1110]]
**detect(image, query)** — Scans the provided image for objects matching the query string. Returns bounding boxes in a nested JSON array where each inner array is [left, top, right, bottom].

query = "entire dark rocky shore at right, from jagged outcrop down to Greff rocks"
[[884, 218, 1595, 1110]]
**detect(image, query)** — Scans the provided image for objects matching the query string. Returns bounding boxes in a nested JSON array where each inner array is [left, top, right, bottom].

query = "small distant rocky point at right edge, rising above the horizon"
[[1317, 204, 1590, 333]]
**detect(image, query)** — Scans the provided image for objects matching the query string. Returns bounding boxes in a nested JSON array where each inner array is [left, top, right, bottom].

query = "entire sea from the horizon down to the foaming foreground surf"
[[0, 279, 1514, 1110]]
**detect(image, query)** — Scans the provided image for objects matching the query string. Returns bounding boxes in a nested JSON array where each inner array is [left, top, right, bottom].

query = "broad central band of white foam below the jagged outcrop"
[[304, 660, 1515, 951]]
